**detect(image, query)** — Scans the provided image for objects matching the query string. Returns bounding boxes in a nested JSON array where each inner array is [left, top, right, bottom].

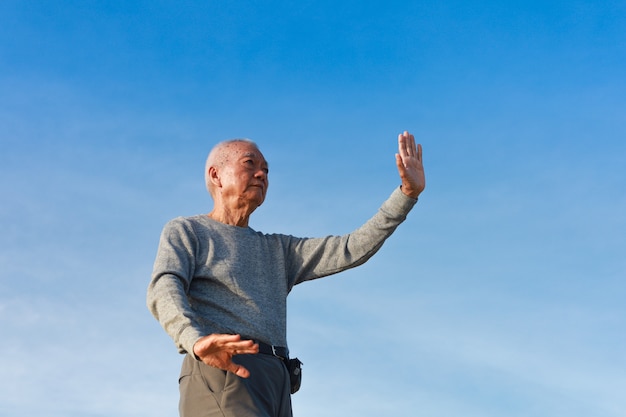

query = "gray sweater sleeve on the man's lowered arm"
[[147, 218, 204, 354]]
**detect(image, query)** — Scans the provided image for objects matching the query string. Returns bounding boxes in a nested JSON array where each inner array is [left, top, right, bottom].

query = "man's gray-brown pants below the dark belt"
[[179, 354, 292, 417]]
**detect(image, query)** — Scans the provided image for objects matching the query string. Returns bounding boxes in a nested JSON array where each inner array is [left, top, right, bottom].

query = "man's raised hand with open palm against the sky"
[[396, 131, 426, 198]]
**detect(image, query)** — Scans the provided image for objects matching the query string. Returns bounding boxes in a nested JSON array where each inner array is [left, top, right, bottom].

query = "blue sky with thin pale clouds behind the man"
[[0, 0, 626, 417]]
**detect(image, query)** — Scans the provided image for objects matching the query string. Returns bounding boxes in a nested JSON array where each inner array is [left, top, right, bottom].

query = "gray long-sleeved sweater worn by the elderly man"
[[147, 188, 417, 353]]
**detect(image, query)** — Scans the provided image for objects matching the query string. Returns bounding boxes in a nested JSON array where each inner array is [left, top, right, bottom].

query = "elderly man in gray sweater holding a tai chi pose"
[[147, 132, 425, 417]]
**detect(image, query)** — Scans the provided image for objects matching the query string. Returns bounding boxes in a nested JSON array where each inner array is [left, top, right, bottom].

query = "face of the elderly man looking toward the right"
[[220, 142, 269, 208]]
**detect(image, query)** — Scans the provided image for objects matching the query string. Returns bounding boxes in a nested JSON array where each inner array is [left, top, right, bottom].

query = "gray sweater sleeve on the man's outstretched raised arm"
[[289, 187, 417, 288]]
